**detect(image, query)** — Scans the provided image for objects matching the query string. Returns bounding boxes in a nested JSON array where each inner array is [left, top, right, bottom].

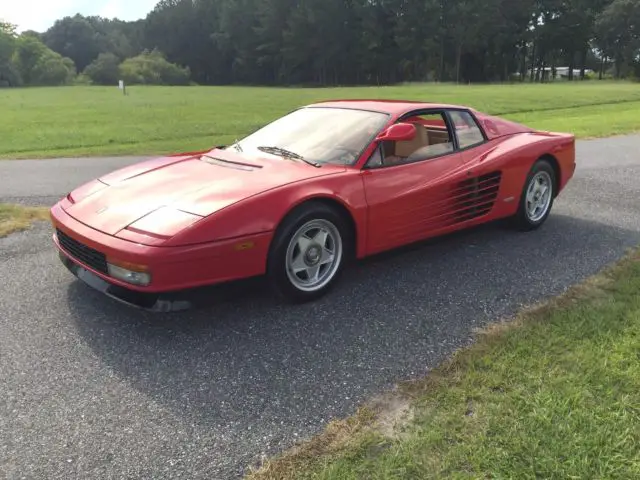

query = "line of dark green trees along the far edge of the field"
[[0, 0, 640, 85]]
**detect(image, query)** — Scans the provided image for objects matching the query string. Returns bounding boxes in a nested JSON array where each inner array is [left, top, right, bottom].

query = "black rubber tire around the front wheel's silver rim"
[[267, 201, 353, 303]]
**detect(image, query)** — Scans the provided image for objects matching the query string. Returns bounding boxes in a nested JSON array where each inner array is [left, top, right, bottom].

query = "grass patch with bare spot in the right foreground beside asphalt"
[[249, 250, 640, 480]]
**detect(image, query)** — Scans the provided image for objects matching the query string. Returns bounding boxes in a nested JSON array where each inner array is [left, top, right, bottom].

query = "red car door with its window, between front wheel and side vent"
[[362, 111, 465, 253]]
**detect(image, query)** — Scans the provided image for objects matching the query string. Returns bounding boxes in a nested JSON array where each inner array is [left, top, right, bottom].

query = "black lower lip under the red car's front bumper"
[[59, 251, 194, 312]]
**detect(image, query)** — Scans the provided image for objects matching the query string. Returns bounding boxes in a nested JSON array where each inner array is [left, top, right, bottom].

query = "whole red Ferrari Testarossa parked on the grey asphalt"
[[51, 100, 575, 311]]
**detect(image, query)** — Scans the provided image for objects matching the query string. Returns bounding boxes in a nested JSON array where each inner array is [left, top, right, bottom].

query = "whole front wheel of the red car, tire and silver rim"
[[267, 202, 351, 302]]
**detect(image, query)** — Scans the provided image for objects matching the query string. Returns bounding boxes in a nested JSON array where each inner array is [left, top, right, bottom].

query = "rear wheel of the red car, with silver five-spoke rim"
[[513, 159, 556, 231]]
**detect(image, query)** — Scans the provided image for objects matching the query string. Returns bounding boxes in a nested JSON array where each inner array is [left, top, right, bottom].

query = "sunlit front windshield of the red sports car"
[[228, 107, 389, 165]]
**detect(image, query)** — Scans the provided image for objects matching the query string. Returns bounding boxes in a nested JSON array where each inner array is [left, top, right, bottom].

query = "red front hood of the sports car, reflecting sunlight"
[[65, 149, 346, 235]]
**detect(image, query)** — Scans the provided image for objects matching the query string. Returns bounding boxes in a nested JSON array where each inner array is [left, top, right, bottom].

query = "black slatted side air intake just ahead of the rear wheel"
[[452, 172, 502, 222]]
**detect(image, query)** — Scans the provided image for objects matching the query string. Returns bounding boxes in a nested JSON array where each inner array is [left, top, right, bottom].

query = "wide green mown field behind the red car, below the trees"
[[0, 81, 640, 158]]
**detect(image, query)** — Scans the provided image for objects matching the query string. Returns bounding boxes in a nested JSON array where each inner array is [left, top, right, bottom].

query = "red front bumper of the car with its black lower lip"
[[51, 204, 271, 312]]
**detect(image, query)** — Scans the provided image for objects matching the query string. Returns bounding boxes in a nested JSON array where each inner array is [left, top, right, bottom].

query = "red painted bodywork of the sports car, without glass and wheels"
[[51, 100, 575, 292]]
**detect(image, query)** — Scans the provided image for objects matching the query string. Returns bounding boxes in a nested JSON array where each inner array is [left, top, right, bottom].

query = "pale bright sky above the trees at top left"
[[0, 0, 159, 32]]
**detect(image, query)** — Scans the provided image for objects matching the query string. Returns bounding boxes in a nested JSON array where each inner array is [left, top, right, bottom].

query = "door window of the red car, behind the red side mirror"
[[383, 113, 453, 166]]
